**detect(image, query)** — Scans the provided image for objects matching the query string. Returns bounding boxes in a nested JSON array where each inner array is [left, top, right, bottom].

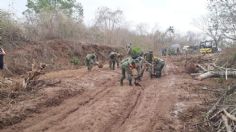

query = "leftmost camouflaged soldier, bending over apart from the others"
[[85, 53, 98, 71]]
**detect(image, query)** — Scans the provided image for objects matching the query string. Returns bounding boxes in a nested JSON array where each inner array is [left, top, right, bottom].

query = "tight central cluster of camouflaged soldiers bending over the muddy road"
[[120, 51, 165, 86]]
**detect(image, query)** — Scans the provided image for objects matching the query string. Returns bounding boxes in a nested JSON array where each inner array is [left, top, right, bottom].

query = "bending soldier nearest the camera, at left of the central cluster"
[[120, 57, 136, 86]]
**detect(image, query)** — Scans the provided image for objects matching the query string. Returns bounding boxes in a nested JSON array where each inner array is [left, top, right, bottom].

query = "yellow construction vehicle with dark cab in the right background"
[[200, 40, 218, 54]]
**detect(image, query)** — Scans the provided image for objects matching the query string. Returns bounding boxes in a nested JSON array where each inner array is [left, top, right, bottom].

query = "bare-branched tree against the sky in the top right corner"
[[195, 0, 236, 46]]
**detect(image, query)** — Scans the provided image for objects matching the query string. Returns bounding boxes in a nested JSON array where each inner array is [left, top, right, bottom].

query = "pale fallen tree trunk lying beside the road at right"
[[196, 71, 236, 80]]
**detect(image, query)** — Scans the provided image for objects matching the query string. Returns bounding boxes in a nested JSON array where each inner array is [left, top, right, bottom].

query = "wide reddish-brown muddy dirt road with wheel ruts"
[[2, 59, 203, 132]]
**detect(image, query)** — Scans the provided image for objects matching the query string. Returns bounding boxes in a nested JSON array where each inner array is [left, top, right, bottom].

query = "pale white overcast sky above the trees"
[[0, 0, 207, 32]]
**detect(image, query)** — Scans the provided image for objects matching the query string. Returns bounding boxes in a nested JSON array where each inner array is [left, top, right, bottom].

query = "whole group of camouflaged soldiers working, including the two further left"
[[85, 46, 165, 86]]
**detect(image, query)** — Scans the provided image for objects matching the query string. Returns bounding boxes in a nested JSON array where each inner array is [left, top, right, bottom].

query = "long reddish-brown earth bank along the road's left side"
[[5, 40, 121, 75]]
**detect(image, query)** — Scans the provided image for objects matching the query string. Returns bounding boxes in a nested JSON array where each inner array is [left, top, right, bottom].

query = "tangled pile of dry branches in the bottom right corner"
[[198, 85, 236, 132]]
